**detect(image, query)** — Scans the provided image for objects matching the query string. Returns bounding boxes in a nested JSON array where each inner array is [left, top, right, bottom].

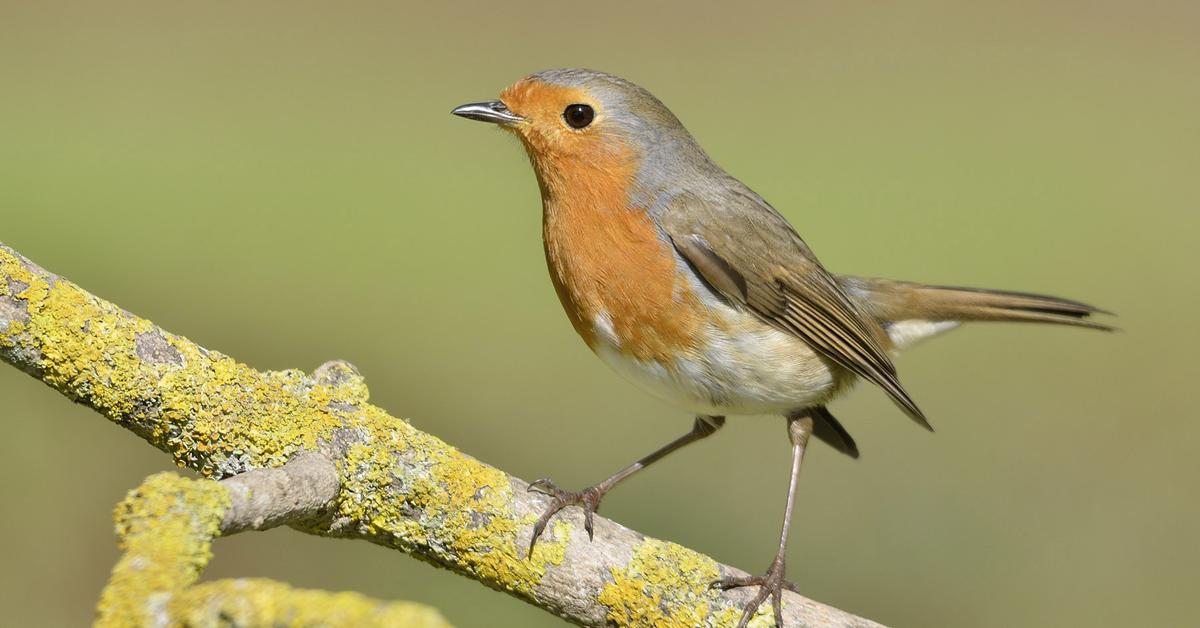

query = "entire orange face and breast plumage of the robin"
[[500, 80, 704, 364]]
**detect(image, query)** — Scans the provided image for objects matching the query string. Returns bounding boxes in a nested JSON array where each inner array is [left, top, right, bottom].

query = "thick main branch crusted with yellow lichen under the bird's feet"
[[0, 245, 877, 626]]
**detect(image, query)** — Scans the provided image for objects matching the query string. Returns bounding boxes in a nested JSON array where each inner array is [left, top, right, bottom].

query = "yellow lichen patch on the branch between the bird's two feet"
[[598, 538, 736, 628]]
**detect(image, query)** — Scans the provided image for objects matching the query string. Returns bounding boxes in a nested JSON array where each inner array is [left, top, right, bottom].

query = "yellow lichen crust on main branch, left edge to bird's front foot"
[[0, 247, 570, 614]]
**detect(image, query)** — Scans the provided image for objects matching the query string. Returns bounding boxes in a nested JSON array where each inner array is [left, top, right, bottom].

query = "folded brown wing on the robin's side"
[[661, 190, 930, 429]]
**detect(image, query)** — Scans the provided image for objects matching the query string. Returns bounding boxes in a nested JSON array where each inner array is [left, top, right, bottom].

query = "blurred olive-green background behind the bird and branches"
[[0, 0, 1200, 627]]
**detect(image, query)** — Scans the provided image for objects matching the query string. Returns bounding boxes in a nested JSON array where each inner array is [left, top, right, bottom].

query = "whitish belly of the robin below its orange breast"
[[595, 305, 852, 415]]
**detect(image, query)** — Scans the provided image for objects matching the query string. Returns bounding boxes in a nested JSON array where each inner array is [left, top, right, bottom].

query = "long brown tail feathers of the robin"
[[840, 277, 1112, 331]]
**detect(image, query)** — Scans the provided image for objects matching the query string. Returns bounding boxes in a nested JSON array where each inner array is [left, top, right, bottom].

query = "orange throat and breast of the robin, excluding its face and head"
[[535, 144, 704, 364]]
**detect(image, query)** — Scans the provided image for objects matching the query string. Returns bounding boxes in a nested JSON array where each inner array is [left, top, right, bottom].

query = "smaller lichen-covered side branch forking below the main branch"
[[96, 465, 450, 628]]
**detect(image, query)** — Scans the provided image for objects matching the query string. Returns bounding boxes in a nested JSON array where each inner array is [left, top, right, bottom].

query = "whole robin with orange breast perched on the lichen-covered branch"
[[451, 68, 1112, 627]]
